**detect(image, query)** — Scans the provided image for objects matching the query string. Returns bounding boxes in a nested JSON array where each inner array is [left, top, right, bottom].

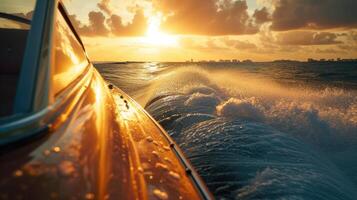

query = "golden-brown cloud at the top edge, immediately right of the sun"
[[154, 0, 259, 35]]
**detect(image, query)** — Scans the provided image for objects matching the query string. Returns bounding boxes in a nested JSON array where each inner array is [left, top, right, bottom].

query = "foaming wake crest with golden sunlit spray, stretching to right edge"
[[144, 69, 357, 143]]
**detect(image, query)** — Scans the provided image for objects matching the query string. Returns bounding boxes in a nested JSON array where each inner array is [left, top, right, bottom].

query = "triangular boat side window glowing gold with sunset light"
[[52, 10, 88, 95]]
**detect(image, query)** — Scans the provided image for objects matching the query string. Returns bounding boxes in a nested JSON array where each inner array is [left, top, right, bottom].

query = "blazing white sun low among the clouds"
[[143, 15, 178, 46]]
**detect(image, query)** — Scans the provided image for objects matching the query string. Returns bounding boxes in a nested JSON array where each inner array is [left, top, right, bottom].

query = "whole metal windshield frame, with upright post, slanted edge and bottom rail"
[[0, 0, 93, 148]]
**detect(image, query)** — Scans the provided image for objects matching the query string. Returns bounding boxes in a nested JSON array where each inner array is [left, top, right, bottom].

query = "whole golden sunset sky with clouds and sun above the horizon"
[[63, 0, 357, 61]]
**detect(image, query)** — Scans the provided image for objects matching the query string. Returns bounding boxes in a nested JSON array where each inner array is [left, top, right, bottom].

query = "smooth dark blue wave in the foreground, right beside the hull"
[[176, 118, 356, 199]]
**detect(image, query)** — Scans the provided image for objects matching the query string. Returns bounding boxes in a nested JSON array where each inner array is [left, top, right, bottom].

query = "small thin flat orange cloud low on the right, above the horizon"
[[277, 31, 342, 45]]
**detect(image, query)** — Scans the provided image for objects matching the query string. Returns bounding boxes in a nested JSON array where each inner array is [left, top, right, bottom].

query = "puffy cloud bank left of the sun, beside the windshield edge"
[[66, 0, 150, 37]]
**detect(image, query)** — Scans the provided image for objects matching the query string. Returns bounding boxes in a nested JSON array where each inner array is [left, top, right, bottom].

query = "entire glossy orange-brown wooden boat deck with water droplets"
[[0, 69, 204, 199]]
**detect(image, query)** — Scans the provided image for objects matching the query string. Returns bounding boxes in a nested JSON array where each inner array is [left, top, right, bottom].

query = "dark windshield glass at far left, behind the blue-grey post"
[[0, 0, 36, 118]]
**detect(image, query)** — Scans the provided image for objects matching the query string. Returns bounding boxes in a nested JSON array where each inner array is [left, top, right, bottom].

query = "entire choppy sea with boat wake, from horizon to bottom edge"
[[96, 62, 357, 199]]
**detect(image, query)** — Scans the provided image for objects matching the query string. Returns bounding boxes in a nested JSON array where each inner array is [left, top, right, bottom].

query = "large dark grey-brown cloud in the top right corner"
[[271, 0, 357, 31]]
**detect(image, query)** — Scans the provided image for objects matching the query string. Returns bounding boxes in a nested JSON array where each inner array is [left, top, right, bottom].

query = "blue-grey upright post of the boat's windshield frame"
[[14, 0, 53, 115]]
